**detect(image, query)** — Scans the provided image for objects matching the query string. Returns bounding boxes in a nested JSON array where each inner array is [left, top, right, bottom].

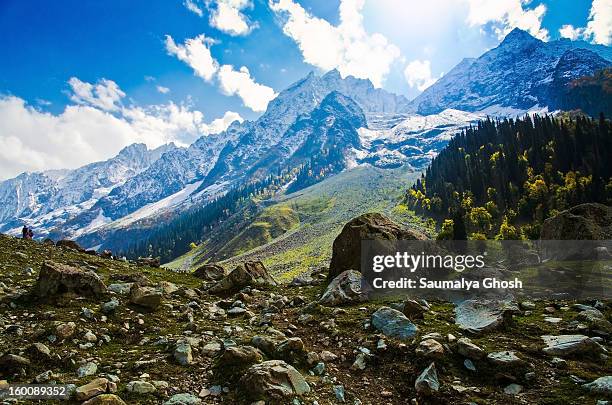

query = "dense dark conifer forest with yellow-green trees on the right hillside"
[[406, 114, 612, 239]]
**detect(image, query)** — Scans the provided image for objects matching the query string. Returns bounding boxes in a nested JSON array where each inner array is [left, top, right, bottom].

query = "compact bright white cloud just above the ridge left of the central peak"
[[219, 65, 276, 111]]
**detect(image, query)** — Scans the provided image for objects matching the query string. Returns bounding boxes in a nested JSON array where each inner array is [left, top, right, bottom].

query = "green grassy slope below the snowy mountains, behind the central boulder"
[[168, 167, 429, 281]]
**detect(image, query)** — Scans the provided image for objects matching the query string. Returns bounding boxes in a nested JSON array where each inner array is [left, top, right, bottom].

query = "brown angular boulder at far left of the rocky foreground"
[[34, 260, 106, 298]]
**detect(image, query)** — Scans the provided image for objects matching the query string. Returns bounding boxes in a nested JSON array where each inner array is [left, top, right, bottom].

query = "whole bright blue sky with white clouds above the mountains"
[[0, 0, 612, 179]]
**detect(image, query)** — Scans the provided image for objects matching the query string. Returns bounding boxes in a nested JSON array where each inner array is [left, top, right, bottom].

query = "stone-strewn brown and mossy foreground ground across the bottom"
[[0, 213, 612, 405]]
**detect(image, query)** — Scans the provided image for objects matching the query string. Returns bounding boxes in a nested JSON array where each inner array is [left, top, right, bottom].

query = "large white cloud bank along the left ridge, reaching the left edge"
[[0, 78, 242, 179]]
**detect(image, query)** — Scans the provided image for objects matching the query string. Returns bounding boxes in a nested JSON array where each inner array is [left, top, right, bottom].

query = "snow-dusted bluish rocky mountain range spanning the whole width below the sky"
[[0, 30, 612, 256]]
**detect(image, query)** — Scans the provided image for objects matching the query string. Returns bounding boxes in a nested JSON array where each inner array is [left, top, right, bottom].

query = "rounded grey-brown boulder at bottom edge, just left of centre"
[[240, 360, 310, 400]]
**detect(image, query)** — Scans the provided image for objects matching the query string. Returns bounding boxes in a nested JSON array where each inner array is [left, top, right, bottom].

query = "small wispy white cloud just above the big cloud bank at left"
[[68, 77, 125, 111]]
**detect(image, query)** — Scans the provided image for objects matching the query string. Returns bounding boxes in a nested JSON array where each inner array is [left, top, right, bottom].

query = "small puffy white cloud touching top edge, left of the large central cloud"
[[210, 0, 256, 36]]
